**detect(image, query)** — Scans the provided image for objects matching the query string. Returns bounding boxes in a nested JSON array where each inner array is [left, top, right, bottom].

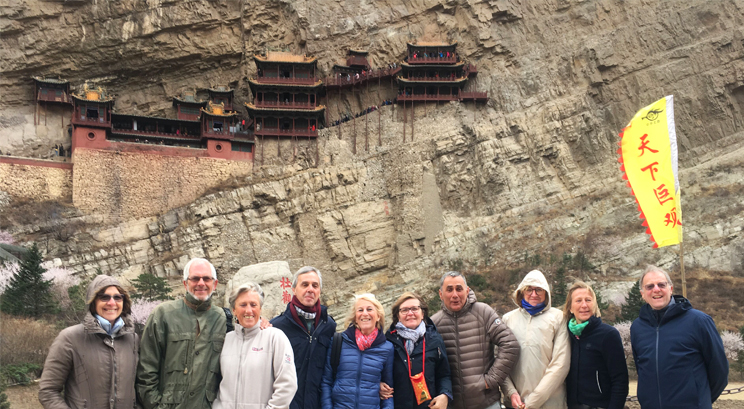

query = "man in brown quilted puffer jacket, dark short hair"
[[431, 271, 519, 409]]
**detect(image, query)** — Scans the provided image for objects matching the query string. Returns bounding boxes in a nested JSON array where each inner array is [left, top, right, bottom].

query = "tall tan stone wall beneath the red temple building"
[[72, 149, 252, 220]]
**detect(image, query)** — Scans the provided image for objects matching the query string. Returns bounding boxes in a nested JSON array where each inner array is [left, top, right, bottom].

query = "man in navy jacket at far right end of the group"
[[630, 266, 728, 409]]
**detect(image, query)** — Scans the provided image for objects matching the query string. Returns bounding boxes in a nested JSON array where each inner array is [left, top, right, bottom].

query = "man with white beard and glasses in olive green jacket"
[[137, 258, 226, 409]]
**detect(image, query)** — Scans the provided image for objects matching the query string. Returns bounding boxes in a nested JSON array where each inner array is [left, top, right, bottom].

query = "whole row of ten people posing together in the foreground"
[[39, 258, 728, 409]]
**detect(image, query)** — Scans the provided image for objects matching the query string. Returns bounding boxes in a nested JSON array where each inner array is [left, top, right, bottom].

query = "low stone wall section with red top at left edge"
[[0, 157, 72, 202]]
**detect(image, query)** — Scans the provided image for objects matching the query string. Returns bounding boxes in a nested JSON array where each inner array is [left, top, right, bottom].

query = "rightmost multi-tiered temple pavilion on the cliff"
[[398, 42, 488, 103]]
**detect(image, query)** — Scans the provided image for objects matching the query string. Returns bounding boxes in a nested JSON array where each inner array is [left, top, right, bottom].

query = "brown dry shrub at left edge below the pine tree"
[[0, 314, 58, 366]]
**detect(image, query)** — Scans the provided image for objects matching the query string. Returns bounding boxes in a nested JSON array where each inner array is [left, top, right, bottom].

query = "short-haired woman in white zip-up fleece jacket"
[[212, 283, 297, 409]]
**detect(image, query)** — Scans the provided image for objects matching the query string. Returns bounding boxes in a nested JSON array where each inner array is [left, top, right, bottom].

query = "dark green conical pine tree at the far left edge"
[[0, 243, 57, 318]]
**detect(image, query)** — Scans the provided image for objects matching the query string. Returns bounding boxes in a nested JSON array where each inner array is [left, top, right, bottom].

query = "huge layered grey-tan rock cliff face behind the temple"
[[0, 0, 744, 314]]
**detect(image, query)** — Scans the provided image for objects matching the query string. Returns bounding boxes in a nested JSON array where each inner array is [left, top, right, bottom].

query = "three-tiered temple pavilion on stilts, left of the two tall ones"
[[245, 52, 325, 160]]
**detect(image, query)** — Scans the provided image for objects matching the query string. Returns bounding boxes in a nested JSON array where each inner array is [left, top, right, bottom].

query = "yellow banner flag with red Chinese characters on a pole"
[[617, 95, 682, 248]]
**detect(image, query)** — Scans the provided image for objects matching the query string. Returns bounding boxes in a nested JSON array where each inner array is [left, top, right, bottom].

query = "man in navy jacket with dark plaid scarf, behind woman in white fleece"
[[271, 266, 336, 409]]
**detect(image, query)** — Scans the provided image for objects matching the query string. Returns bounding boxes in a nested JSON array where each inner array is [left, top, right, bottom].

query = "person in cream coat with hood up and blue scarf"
[[501, 270, 571, 409]]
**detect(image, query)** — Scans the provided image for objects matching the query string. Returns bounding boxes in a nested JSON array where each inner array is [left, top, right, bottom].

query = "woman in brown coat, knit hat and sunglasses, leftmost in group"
[[39, 275, 139, 409]]
